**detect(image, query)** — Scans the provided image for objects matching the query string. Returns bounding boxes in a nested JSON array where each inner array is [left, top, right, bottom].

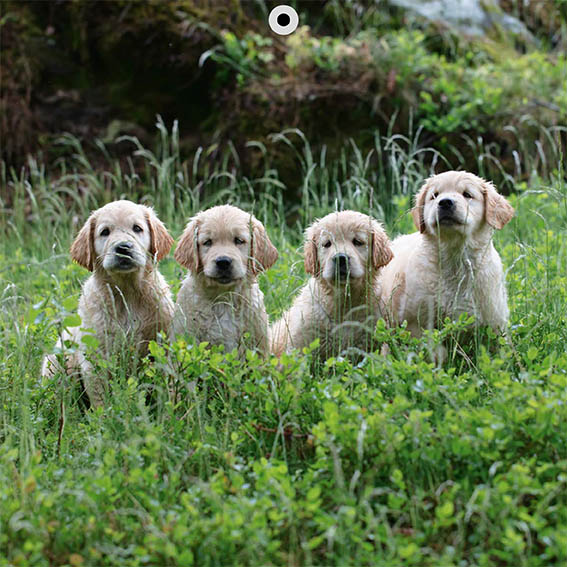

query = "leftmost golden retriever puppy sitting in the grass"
[[42, 201, 173, 407]]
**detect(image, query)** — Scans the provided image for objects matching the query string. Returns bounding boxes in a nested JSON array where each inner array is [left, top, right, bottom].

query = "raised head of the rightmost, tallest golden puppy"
[[412, 171, 514, 238]]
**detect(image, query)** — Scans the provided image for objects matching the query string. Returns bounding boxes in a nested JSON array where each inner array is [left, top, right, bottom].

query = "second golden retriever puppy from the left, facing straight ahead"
[[172, 205, 278, 356]]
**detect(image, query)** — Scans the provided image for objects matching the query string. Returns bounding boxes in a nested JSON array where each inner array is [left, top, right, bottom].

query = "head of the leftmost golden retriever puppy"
[[71, 200, 173, 273]]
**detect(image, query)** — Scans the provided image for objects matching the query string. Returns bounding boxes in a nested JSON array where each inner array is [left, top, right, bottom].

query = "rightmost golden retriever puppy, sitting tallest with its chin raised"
[[381, 171, 514, 362]]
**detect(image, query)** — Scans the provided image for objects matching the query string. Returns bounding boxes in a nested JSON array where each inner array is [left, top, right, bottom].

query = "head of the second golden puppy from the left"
[[175, 205, 278, 288]]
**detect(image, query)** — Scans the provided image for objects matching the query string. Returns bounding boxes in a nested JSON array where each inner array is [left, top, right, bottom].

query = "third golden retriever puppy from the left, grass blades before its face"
[[270, 211, 392, 359]]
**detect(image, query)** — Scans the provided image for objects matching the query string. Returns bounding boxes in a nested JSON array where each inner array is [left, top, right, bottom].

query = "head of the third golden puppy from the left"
[[305, 211, 392, 286]]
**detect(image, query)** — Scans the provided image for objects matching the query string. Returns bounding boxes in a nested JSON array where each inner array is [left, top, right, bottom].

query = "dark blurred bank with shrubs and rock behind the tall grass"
[[0, 0, 567, 200]]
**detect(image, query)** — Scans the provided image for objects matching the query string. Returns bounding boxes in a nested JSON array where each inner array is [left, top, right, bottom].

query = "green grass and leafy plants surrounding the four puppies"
[[0, 123, 567, 567]]
